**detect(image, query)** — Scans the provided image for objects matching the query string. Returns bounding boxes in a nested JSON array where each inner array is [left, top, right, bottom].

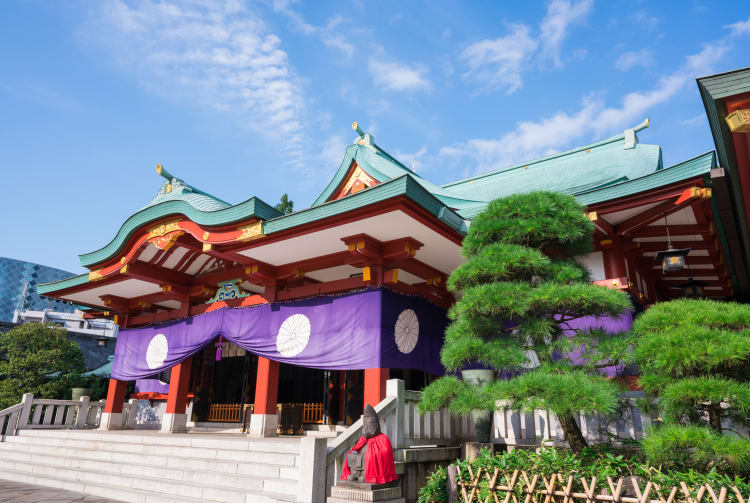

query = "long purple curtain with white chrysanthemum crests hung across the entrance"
[[112, 289, 446, 380]]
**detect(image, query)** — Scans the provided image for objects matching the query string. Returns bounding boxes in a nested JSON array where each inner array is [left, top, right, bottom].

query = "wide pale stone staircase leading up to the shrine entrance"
[[0, 430, 300, 503]]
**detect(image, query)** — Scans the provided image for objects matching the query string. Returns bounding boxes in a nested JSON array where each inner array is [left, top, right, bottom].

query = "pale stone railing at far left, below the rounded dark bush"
[[0, 393, 136, 436]]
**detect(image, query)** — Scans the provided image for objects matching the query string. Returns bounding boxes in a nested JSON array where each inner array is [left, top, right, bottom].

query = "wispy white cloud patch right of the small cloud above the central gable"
[[461, 24, 537, 94]]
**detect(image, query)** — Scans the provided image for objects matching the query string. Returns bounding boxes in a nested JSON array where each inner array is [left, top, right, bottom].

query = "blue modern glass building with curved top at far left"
[[0, 257, 75, 322]]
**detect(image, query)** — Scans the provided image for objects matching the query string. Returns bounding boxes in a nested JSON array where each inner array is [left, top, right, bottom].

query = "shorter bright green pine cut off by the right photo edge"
[[633, 299, 750, 473]]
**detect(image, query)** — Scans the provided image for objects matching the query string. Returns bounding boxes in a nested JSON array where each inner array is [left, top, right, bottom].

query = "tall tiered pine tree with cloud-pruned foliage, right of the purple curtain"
[[420, 192, 630, 452]]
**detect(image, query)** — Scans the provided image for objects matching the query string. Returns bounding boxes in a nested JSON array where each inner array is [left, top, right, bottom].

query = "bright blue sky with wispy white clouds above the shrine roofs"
[[0, 0, 750, 272]]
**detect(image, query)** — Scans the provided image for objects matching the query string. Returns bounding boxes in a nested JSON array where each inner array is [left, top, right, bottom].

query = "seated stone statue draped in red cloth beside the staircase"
[[341, 405, 398, 484]]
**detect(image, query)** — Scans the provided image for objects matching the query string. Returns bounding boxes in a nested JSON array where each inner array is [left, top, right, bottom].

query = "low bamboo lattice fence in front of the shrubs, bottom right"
[[457, 467, 750, 503]]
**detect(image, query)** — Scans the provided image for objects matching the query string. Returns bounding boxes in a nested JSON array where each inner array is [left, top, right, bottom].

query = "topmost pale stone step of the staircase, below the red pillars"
[[18, 429, 299, 454]]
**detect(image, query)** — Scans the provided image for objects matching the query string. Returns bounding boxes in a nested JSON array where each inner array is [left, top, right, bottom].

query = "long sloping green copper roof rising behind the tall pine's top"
[[443, 124, 663, 209]]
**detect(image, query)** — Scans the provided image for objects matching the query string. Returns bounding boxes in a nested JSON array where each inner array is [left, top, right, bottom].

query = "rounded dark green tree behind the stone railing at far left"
[[0, 323, 86, 409]]
